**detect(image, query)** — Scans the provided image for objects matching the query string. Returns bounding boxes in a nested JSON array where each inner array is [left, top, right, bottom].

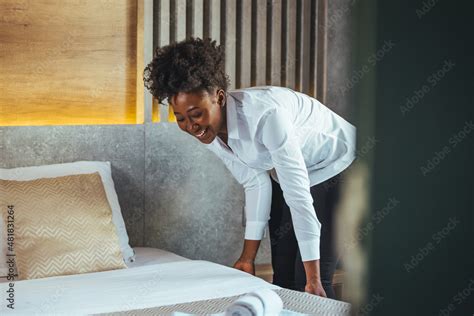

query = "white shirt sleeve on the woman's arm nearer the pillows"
[[217, 157, 272, 240]]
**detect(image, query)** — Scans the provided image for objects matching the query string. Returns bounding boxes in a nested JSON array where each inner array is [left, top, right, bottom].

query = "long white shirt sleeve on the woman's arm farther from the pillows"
[[260, 108, 321, 261]]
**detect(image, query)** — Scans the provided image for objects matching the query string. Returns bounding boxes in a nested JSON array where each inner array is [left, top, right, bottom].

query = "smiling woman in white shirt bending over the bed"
[[144, 38, 355, 297]]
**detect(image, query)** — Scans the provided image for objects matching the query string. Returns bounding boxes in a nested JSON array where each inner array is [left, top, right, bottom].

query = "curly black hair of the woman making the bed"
[[143, 37, 230, 103]]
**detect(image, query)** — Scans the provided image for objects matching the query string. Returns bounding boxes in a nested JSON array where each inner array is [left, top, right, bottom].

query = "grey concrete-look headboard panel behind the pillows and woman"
[[0, 123, 270, 265]]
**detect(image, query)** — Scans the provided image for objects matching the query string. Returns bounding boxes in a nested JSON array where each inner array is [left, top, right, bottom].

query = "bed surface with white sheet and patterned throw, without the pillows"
[[0, 247, 350, 315]]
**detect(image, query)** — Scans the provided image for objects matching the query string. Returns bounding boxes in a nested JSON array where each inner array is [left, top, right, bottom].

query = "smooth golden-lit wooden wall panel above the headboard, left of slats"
[[0, 0, 137, 125]]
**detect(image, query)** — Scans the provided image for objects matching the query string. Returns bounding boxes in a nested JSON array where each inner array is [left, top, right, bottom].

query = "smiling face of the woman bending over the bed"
[[171, 89, 227, 144]]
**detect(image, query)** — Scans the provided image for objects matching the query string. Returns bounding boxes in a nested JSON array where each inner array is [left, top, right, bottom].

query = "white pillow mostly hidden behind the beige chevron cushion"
[[0, 161, 135, 276]]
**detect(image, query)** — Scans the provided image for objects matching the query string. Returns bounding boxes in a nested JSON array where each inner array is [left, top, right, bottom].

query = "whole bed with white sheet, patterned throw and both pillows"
[[0, 161, 350, 315]]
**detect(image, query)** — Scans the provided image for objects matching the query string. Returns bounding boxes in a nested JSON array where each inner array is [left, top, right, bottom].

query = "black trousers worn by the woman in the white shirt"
[[268, 175, 340, 298]]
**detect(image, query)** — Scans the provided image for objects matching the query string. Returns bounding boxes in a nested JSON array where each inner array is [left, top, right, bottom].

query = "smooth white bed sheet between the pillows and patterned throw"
[[0, 248, 280, 315]]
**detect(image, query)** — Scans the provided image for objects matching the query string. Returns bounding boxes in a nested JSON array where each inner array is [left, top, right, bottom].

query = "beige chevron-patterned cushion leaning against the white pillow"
[[0, 172, 126, 280]]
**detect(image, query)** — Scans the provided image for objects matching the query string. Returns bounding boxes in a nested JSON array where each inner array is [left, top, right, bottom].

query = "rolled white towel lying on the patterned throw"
[[225, 289, 283, 316]]
